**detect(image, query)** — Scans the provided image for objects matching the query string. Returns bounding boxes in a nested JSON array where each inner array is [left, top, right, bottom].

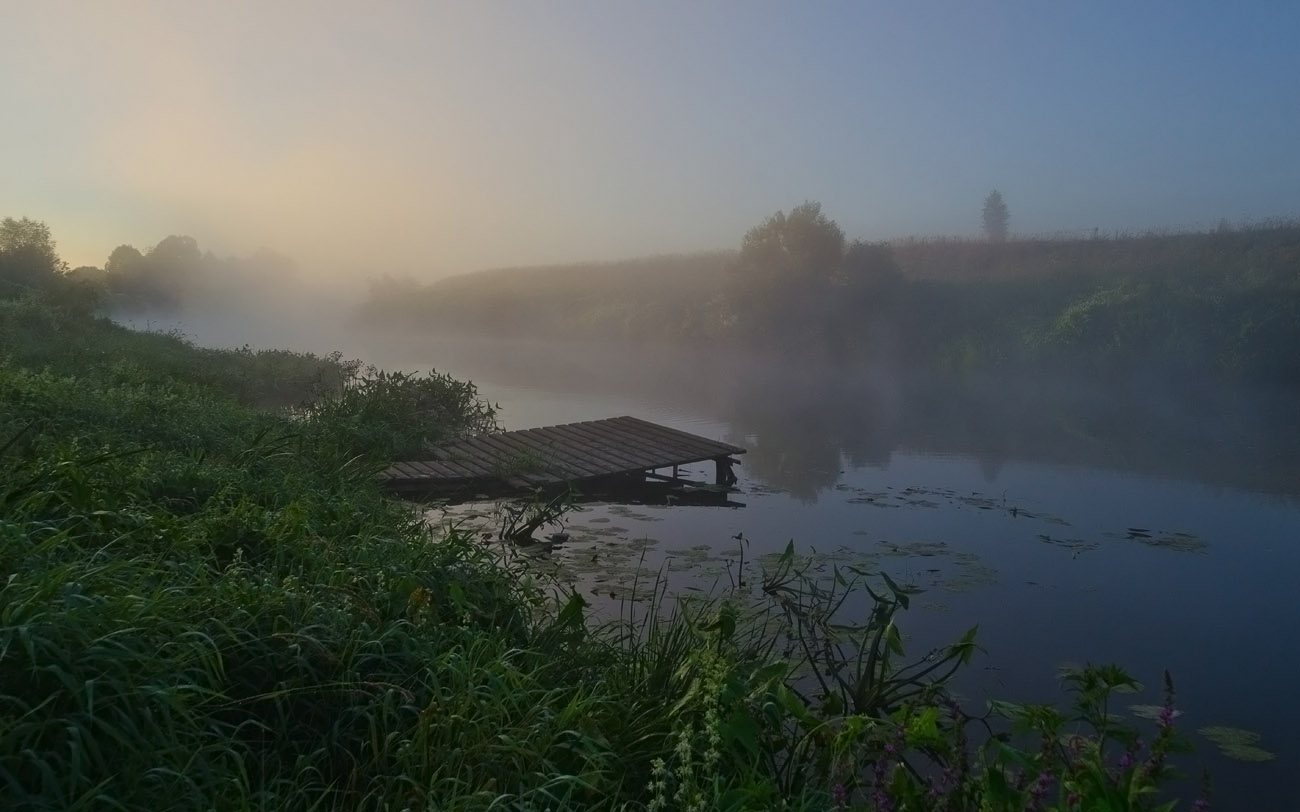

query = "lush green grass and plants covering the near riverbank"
[[0, 218, 1201, 811]]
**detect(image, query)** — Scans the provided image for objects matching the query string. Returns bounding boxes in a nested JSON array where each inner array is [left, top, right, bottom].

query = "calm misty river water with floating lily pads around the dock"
[[374, 335, 1300, 809]]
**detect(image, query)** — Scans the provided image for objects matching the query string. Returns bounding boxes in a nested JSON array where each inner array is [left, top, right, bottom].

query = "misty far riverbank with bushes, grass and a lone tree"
[[361, 204, 1300, 387]]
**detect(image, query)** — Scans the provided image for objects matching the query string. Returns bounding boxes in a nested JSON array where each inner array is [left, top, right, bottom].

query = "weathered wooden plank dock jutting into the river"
[[381, 417, 745, 492]]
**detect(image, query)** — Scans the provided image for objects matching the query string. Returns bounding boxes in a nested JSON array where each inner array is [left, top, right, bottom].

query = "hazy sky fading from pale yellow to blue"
[[0, 0, 1300, 281]]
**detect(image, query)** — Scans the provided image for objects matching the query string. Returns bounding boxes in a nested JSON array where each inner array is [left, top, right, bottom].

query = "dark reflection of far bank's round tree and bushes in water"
[[716, 375, 1300, 500]]
